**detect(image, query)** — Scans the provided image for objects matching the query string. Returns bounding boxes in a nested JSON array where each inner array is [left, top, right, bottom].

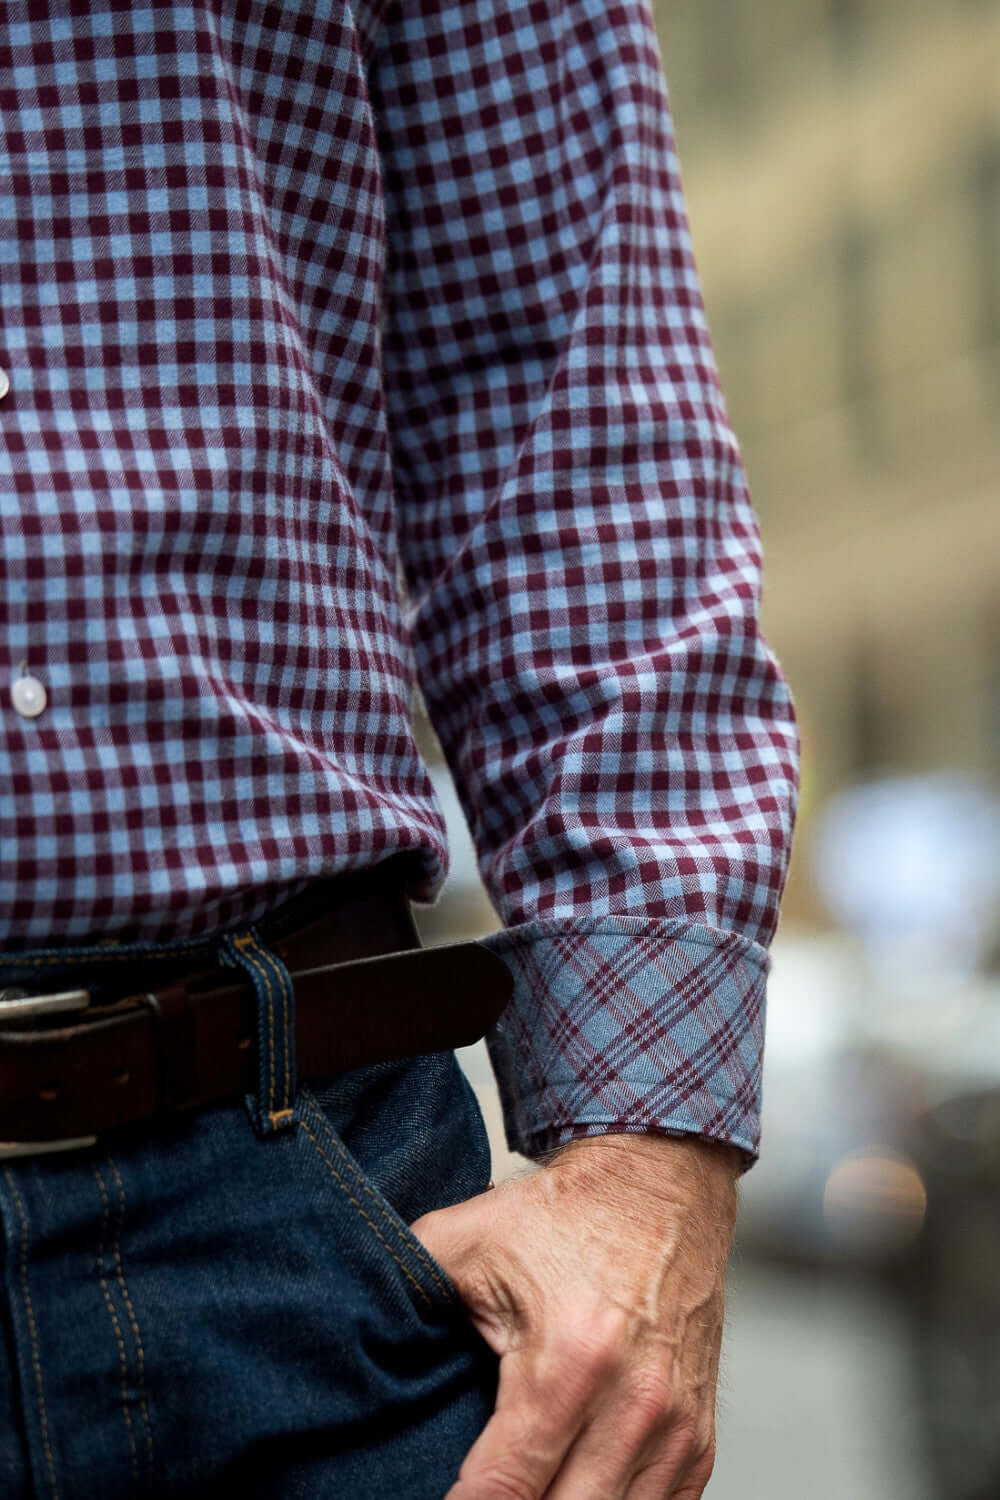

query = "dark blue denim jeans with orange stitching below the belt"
[[0, 918, 498, 1500]]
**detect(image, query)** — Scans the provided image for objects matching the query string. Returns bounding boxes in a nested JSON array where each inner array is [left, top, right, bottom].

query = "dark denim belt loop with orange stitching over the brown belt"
[[219, 927, 295, 1136]]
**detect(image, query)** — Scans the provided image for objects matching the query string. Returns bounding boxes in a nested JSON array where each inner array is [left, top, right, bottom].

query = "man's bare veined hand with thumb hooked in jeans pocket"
[[414, 1136, 739, 1500]]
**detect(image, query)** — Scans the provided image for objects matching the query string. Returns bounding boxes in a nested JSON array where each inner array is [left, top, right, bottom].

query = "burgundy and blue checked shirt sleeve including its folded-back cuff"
[[370, 0, 798, 1158]]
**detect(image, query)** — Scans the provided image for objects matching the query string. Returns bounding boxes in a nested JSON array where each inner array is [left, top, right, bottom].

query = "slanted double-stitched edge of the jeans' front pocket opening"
[[290, 1085, 460, 1313]]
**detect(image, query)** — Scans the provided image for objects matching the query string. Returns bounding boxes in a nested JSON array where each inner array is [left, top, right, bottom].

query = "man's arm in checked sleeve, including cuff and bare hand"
[[370, 0, 796, 1500]]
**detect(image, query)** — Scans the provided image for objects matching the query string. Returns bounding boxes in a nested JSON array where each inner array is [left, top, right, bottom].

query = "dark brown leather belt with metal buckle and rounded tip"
[[0, 857, 513, 1157]]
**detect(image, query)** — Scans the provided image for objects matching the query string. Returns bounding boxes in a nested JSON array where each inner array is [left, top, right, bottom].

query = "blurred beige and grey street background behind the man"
[[421, 0, 1000, 1500]]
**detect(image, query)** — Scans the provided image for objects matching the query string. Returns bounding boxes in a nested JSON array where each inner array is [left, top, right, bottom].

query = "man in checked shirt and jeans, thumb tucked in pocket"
[[0, 0, 796, 1500]]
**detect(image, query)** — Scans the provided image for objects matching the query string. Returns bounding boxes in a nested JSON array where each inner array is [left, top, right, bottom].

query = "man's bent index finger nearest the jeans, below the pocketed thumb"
[[445, 1350, 592, 1500]]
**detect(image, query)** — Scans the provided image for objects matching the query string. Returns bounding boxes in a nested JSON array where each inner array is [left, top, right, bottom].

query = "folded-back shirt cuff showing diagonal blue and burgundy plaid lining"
[[484, 917, 769, 1161]]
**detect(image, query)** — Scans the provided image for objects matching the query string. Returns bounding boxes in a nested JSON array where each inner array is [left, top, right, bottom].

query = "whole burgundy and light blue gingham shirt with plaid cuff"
[[0, 0, 796, 1152]]
